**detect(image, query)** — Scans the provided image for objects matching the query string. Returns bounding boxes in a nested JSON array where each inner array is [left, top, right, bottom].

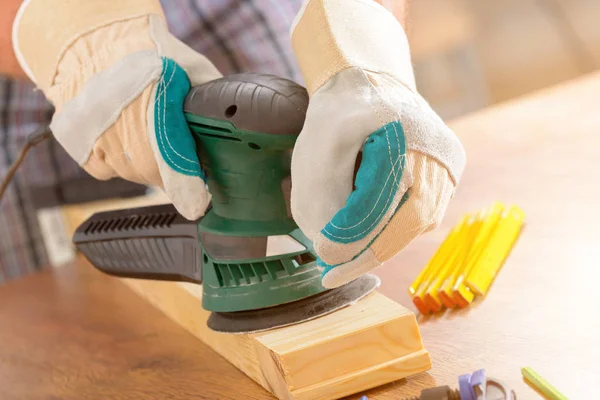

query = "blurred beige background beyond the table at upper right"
[[408, 0, 600, 119]]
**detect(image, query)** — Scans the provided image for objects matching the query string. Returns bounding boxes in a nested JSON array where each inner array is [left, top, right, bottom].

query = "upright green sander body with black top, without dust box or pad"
[[184, 74, 325, 312]]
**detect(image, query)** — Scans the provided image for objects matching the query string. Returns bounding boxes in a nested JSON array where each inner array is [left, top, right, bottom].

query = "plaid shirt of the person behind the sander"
[[0, 0, 302, 284]]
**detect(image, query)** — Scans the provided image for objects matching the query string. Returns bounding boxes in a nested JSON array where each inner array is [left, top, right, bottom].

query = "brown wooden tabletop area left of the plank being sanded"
[[0, 261, 272, 400]]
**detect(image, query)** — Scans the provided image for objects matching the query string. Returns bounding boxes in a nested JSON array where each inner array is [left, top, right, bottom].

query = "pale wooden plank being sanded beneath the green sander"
[[123, 279, 431, 400]]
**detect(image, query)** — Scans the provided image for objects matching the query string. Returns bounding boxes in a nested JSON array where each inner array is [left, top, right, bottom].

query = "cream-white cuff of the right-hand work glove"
[[292, 0, 416, 95]]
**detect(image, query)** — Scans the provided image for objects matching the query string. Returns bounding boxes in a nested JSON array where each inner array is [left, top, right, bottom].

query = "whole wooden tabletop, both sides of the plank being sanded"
[[0, 74, 600, 400]]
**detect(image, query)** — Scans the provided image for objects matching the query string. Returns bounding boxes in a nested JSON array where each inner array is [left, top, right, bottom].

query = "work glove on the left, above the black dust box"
[[13, 0, 221, 219]]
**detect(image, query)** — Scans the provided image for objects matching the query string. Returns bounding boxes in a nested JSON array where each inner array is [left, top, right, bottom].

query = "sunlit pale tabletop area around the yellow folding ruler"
[[369, 73, 600, 400]]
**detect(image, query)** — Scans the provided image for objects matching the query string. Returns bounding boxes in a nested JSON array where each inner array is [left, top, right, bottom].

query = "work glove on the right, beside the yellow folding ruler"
[[291, 0, 465, 288]]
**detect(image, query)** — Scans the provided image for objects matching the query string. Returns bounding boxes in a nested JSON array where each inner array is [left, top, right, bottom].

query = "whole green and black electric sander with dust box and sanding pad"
[[73, 73, 380, 333]]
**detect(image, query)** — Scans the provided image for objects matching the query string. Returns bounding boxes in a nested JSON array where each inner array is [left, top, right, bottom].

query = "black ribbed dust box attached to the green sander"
[[73, 204, 202, 283]]
